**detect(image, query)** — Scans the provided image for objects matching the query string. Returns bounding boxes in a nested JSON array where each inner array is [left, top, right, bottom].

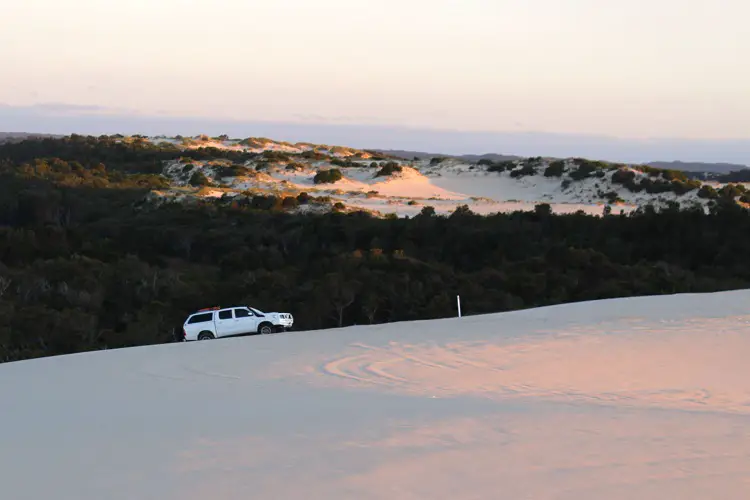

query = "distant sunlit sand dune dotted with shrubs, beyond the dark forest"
[[157, 137, 728, 217]]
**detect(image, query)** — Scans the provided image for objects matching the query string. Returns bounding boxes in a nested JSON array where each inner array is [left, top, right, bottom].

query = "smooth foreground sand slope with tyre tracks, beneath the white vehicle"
[[0, 291, 750, 500]]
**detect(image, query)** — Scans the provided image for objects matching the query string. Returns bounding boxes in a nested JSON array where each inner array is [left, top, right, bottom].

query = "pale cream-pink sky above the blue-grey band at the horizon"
[[0, 0, 750, 159]]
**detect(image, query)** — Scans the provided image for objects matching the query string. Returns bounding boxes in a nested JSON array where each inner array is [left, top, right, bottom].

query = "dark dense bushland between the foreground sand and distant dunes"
[[0, 138, 750, 361]]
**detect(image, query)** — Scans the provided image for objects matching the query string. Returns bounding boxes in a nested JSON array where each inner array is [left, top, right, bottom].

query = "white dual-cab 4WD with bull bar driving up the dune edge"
[[182, 306, 294, 341]]
